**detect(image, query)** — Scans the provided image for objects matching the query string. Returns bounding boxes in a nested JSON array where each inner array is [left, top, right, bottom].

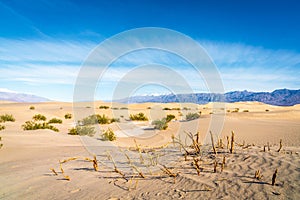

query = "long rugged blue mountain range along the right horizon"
[[117, 89, 300, 106]]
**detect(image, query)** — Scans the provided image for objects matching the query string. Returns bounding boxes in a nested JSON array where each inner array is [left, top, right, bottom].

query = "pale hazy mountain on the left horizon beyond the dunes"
[[0, 92, 50, 103]]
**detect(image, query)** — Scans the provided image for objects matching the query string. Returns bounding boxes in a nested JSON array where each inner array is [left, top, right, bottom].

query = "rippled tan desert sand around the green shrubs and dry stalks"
[[0, 102, 300, 199]]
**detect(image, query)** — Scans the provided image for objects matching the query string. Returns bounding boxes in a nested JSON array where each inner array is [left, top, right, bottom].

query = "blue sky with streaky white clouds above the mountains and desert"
[[0, 0, 300, 101]]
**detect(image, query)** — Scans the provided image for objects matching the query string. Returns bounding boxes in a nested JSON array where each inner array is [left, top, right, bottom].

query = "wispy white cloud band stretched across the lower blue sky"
[[0, 38, 300, 100]]
